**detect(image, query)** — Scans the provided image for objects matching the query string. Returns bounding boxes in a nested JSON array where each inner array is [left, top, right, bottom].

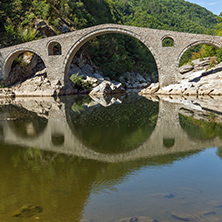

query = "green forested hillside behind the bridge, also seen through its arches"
[[0, 0, 222, 77]]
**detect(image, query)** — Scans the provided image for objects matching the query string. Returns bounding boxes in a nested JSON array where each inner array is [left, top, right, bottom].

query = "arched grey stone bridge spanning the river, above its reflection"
[[0, 24, 222, 86]]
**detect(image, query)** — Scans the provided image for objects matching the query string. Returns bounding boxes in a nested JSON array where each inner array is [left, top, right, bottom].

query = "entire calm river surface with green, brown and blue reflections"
[[0, 93, 222, 222]]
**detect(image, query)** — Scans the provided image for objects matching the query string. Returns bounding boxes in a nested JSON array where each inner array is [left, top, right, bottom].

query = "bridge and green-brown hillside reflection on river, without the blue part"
[[0, 95, 221, 221]]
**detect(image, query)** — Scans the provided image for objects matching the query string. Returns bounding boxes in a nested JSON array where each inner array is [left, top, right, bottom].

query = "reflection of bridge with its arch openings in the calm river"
[[1, 93, 220, 162]]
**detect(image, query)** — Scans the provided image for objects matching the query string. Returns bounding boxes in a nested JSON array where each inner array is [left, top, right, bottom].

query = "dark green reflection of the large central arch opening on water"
[[67, 93, 158, 153]]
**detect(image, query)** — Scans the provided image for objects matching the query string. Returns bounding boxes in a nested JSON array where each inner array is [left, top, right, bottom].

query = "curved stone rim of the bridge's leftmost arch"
[[3, 48, 46, 80]]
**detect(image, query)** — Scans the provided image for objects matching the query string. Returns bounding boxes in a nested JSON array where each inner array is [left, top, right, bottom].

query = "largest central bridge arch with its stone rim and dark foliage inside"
[[64, 29, 159, 89]]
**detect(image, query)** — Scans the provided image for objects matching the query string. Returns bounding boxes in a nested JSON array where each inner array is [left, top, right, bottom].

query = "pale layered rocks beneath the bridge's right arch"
[[140, 58, 222, 96]]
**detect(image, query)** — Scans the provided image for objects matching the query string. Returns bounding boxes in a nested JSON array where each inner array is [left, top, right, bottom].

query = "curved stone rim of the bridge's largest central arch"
[[63, 27, 160, 82]]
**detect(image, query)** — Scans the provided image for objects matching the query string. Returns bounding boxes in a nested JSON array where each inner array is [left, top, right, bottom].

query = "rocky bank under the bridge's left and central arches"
[[0, 52, 154, 98]]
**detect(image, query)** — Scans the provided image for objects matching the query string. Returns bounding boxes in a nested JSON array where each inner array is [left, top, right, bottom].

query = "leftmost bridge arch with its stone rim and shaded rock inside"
[[4, 49, 46, 86]]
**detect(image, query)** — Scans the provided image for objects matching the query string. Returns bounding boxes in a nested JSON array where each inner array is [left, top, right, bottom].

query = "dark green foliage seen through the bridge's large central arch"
[[77, 34, 157, 81]]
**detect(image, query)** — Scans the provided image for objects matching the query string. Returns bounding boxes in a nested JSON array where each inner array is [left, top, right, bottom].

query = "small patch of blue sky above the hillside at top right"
[[188, 0, 222, 15]]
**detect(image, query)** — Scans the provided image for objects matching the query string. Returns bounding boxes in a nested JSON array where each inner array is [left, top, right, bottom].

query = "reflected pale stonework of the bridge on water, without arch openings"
[[1, 100, 221, 162]]
